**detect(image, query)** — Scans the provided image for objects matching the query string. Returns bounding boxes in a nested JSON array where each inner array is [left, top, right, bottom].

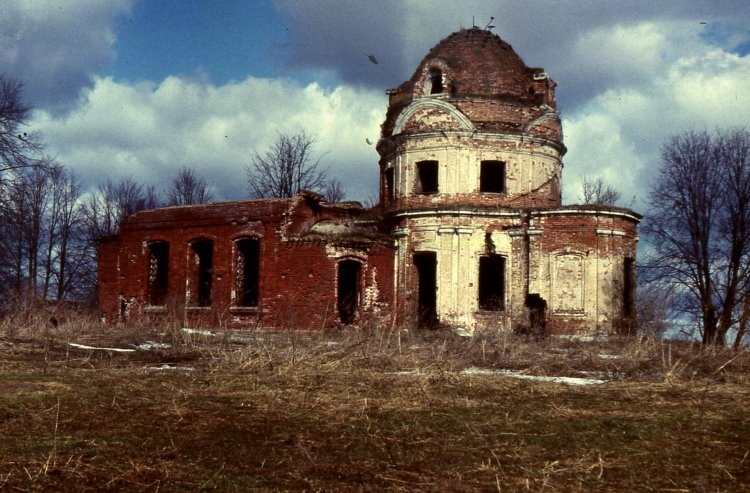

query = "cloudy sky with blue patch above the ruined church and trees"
[[0, 0, 750, 208]]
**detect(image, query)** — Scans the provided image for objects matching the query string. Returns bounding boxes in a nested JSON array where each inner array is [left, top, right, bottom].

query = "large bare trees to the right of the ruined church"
[[643, 129, 750, 345]]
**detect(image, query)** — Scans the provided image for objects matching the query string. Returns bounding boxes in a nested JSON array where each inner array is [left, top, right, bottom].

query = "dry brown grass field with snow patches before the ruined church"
[[0, 317, 750, 492]]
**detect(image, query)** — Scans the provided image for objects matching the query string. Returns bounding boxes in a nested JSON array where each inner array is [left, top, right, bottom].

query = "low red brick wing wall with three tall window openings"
[[99, 196, 400, 329]]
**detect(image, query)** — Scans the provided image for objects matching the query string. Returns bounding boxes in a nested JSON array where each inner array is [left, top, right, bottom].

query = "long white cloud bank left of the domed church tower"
[[33, 77, 385, 199]]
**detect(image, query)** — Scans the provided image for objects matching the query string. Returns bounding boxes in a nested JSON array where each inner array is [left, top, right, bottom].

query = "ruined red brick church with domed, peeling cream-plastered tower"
[[99, 28, 640, 333]]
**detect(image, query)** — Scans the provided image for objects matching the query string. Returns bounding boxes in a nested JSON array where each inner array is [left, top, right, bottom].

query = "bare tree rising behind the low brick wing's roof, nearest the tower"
[[247, 131, 326, 198]]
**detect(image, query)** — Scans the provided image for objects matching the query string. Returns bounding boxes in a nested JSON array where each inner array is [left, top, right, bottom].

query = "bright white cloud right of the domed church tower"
[[563, 43, 750, 208]]
